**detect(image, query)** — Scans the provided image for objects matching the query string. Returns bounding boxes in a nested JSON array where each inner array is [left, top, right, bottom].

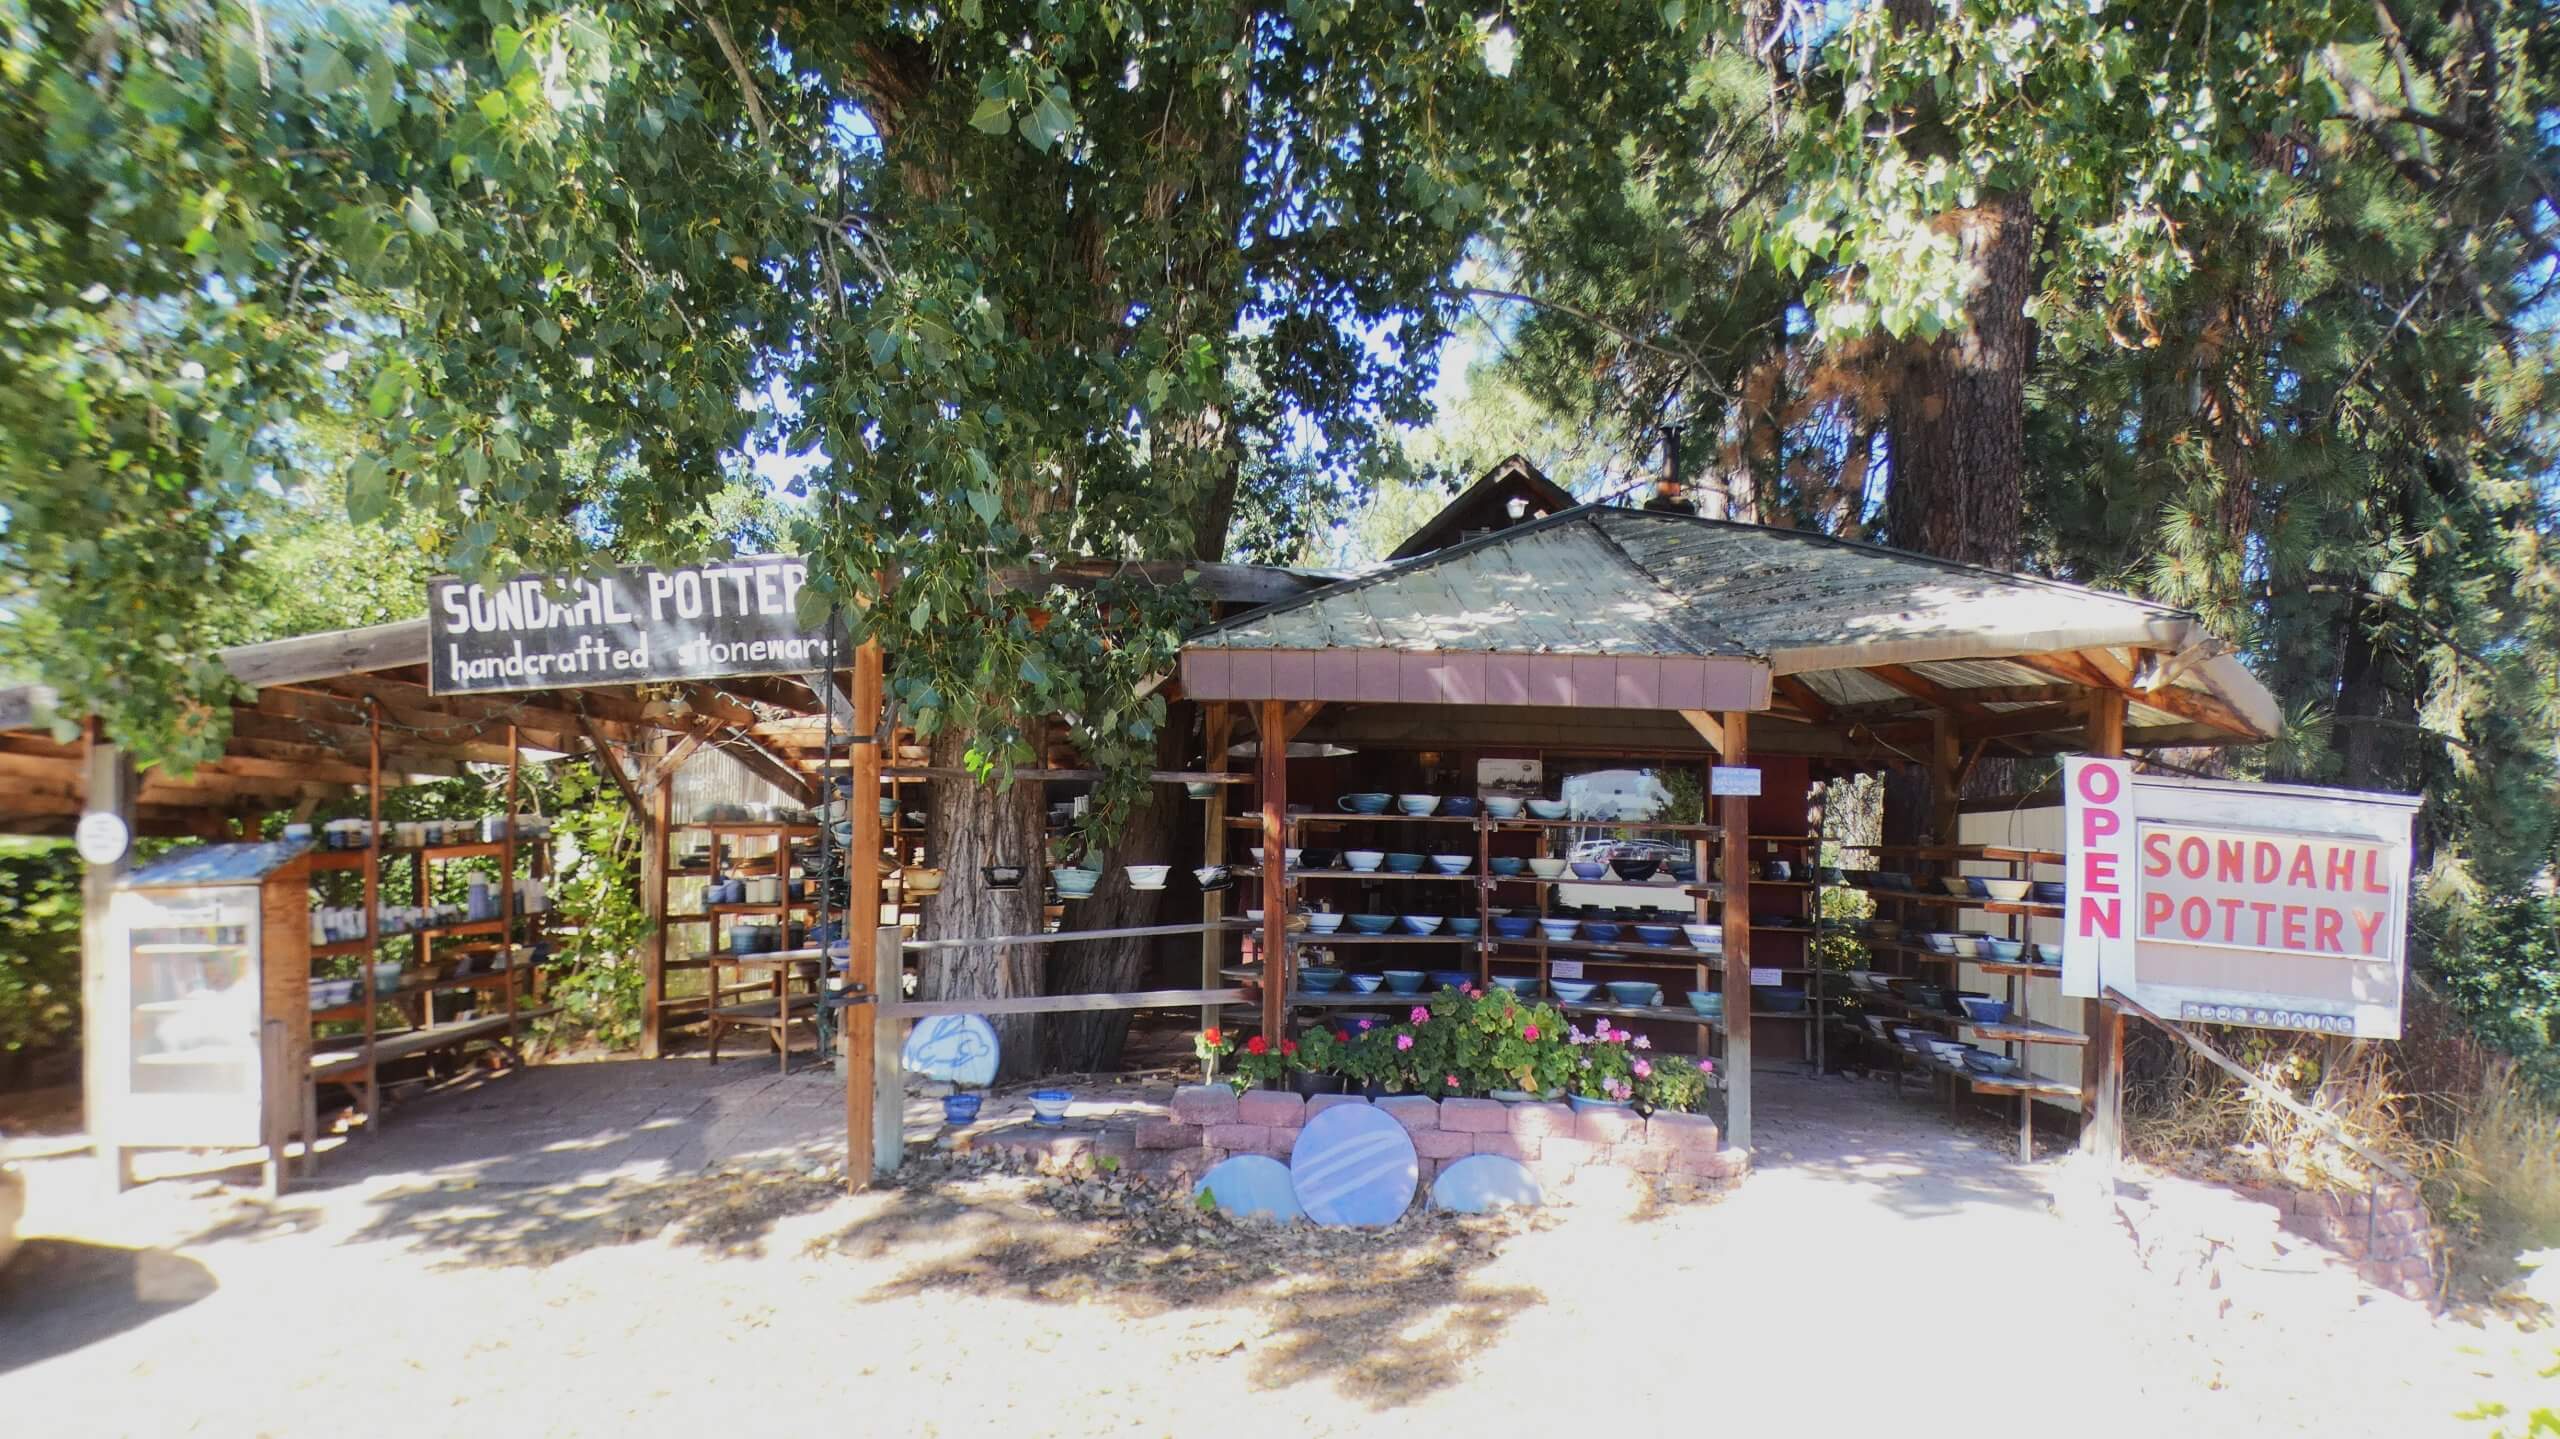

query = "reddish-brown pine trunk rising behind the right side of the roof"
[[1884, 195, 2035, 568]]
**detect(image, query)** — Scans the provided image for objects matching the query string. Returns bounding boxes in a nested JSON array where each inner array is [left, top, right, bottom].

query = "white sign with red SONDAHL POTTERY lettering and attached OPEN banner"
[[2063, 755, 2417, 1040]]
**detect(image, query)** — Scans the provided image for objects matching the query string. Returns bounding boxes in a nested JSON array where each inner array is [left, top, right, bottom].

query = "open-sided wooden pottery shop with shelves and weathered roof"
[[0, 458, 2276, 1188]]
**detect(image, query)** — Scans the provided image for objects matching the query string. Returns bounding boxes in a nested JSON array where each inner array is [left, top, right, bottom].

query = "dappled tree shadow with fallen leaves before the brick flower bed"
[[812, 1162, 1544, 1411]]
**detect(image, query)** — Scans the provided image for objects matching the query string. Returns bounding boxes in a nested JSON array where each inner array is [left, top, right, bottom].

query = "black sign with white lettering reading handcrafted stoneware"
[[428, 556, 827, 694]]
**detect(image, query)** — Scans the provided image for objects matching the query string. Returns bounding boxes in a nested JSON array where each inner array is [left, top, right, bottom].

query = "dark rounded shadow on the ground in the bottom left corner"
[[0, 1239, 220, 1362]]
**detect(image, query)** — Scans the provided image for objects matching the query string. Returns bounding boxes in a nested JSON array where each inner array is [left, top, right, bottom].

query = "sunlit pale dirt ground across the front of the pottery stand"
[[0, 1060, 2560, 1436]]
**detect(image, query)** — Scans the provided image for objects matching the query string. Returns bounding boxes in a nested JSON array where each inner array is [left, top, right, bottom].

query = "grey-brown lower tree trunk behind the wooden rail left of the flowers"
[[901, 732, 1044, 1081]]
